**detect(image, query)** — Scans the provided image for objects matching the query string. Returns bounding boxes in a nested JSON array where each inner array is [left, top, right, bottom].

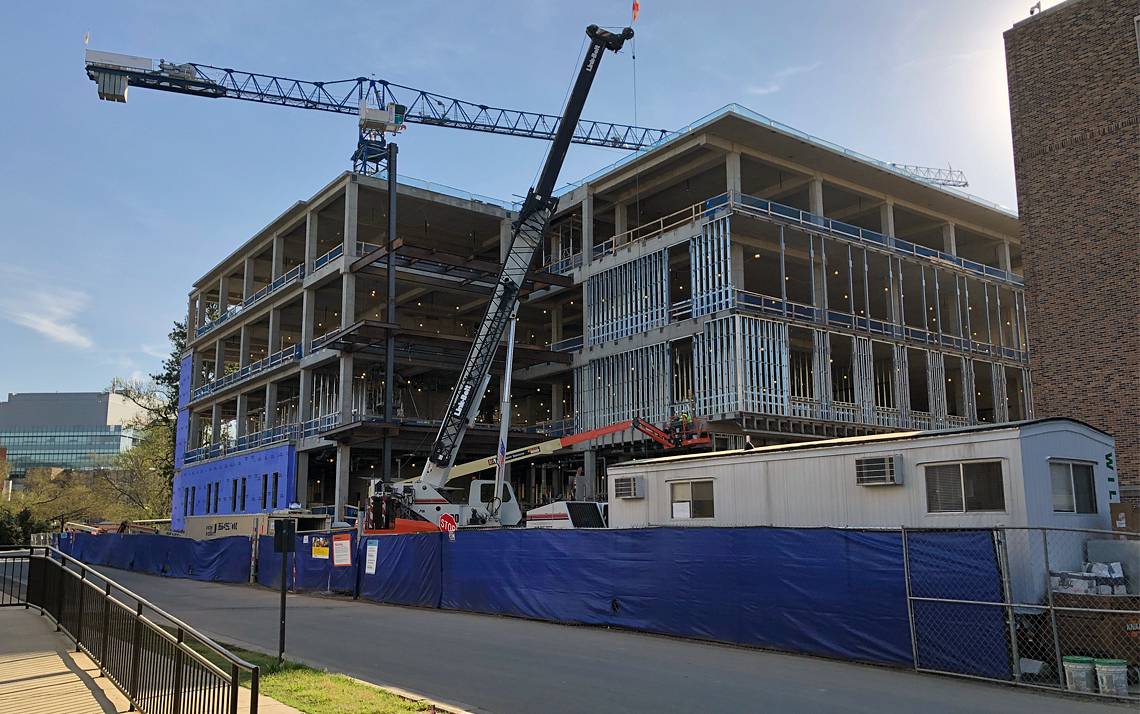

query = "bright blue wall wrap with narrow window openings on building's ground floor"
[[171, 444, 296, 530]]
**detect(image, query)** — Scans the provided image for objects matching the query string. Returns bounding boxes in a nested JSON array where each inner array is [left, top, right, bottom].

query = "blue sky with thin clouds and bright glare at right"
[[0, 0, 1053, 399]]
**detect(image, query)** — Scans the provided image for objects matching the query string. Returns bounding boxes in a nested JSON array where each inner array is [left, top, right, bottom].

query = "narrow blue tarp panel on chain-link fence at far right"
[[906, 530, 1012, 679]]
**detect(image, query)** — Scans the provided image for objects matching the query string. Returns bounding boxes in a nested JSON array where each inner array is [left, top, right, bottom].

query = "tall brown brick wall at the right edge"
[[1004, 0, 1140, 503]]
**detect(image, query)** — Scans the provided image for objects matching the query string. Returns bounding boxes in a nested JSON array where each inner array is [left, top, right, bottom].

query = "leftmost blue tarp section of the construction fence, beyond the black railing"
[[70, 533, 251, 583]]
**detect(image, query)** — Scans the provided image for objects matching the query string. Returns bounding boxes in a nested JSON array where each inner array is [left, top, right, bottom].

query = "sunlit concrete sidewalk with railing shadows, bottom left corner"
[[0, 607, 301, 714]]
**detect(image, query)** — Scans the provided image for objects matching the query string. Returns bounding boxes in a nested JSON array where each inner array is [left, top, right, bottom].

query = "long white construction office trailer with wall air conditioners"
[[608, 419, 1119, 530]]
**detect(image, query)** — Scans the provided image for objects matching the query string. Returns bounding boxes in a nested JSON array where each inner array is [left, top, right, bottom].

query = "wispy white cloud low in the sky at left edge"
[[0, 268, 95, 349]]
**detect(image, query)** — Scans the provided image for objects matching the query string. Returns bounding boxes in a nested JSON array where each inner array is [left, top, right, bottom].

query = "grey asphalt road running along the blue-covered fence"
[[91, 568, 1132, 714]]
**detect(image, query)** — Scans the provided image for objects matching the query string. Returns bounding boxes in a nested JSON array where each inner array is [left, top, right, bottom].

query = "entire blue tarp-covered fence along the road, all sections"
[[60, 528, 1010, 679]]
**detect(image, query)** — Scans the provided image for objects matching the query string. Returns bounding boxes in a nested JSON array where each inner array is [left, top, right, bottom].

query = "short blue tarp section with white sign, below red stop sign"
[[357, 533, 443, 608]]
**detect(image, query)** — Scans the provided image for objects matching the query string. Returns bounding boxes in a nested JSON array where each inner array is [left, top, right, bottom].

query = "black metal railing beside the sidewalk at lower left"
[[0, 545, 260, 714]]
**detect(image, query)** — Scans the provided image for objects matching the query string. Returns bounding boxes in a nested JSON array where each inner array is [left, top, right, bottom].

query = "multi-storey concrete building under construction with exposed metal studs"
[[173, 106, 1032, 527]]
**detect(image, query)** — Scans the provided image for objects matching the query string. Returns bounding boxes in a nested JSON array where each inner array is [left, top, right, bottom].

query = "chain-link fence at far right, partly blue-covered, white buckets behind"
[[903, 528, 1140, 700]]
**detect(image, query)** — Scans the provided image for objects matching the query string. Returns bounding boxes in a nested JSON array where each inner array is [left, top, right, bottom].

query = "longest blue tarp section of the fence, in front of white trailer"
[[440, 528, 912, 664]]
